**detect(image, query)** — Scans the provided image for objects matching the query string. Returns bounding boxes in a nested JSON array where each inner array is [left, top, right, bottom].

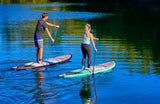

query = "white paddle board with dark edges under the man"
[[11, 54, 72, 70]]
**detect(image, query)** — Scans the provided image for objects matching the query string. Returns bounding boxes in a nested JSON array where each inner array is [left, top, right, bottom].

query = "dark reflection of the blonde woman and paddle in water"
[[79, 76, 97, 104]]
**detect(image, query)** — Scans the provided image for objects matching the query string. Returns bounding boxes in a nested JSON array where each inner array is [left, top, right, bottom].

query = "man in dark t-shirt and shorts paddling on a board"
[[34, 13, 59, 64]]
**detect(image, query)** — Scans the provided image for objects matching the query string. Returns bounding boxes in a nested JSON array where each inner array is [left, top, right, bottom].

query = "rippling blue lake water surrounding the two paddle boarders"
[[0, 3, 160, 104]]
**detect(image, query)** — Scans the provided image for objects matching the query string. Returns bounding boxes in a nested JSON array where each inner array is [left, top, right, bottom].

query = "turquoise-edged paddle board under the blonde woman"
[[59, 61, 115, 78]]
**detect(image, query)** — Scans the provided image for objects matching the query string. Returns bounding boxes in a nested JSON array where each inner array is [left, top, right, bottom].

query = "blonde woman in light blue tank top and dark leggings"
[[81, 24, 99, 70]]
